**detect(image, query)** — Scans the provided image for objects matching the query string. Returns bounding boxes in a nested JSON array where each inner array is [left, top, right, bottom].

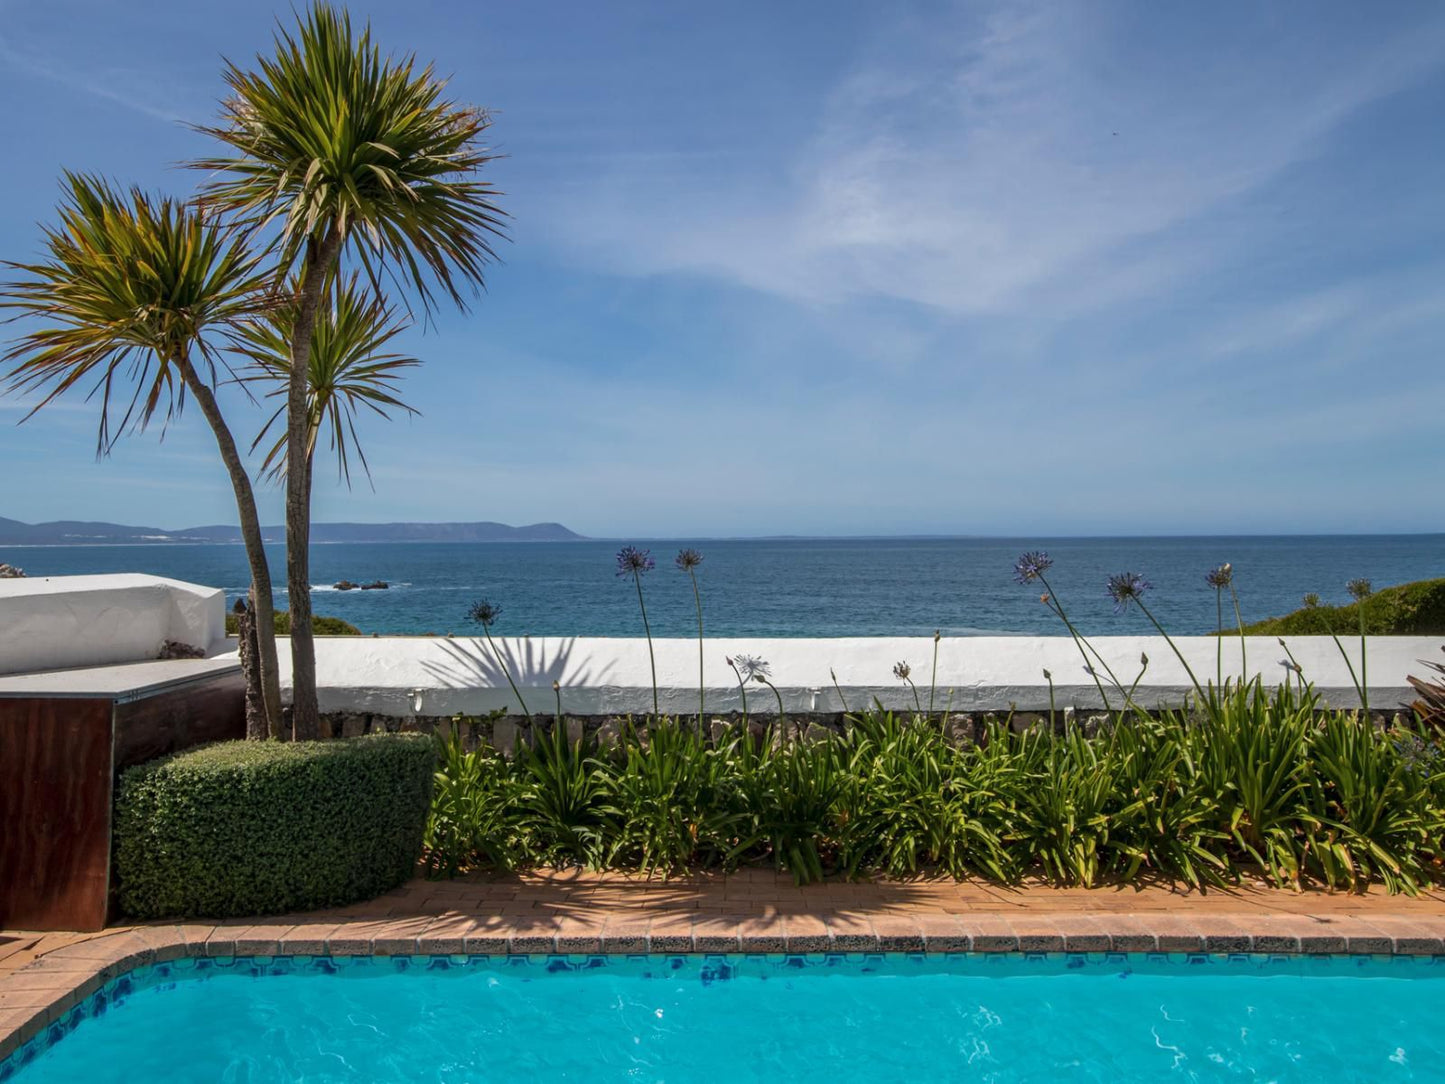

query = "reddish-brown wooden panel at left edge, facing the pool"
[[0, 700, 111, 929]]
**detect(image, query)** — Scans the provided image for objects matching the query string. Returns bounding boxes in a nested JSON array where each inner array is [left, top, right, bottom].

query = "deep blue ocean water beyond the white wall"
[[0, 535, 1445, 636]]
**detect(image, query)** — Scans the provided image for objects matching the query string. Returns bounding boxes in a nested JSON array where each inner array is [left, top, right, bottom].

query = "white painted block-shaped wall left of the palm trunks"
[[0, 574, 227, 674]]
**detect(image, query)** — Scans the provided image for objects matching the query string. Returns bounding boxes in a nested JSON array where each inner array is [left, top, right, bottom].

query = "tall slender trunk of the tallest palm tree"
[[286, 225, 342, 741]]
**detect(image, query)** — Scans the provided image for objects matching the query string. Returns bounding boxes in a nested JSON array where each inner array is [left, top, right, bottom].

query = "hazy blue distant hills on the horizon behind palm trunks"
[[0, 517, 582, 546]]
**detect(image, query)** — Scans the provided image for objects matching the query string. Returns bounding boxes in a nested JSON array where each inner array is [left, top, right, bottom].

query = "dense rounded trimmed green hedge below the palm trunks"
[[116, 734, 436, 918]]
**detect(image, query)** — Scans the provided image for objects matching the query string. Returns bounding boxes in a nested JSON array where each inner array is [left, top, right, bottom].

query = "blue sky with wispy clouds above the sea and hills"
[[0, 0, 1445, 536]]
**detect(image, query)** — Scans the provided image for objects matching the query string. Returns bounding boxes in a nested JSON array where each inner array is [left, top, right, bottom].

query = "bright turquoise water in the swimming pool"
[[0, 955, 1445, 1084]]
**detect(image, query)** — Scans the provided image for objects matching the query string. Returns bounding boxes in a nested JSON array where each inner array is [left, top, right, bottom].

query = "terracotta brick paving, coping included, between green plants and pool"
[[0, 870, 1445, 1058]]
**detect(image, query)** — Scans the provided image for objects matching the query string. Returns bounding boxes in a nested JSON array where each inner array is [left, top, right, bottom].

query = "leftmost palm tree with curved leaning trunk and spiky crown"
[[0, 173, 282, 737]]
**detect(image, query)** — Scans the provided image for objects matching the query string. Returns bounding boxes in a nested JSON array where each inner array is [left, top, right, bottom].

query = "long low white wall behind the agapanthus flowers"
[[262, 636, 1442, 715]]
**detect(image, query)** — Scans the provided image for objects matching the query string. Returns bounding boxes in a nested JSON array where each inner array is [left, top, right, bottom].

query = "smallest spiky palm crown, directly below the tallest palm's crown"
[[236, 275, 420, 486]]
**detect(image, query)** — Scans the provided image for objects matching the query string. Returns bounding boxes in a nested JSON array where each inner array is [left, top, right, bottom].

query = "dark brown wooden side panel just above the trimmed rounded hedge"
[[116, 671, 246, 773]]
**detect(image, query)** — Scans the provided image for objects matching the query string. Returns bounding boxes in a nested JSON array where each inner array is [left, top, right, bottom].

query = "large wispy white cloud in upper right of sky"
[[537, 3, 1445, 314]]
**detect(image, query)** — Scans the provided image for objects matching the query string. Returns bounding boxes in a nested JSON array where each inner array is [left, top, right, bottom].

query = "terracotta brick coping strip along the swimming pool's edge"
[[0, 905, 1445, 1059]]
